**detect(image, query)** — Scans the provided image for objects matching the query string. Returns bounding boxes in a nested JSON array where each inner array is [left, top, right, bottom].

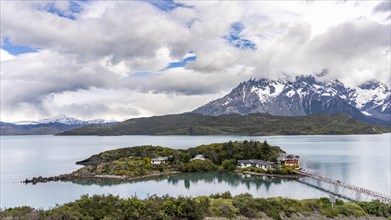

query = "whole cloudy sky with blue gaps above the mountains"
[[0, 0, 391, 122]]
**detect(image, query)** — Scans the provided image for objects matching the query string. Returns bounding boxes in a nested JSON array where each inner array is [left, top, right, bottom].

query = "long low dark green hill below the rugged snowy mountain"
[[60, 113, 389, 135]]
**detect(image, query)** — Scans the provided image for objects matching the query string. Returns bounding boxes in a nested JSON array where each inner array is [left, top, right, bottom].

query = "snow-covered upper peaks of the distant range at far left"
[[13, 115, 115, 125]]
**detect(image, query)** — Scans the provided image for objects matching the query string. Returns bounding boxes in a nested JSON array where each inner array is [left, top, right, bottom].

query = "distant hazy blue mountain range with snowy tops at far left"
[[0, 115, 117, 135]]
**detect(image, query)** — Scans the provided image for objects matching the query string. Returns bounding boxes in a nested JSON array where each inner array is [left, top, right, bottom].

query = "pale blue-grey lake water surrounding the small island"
[[0, 134, 391, 208]]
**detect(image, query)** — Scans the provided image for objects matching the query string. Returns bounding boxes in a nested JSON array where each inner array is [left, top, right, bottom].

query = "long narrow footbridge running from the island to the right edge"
[[294, 170, 391, 204]]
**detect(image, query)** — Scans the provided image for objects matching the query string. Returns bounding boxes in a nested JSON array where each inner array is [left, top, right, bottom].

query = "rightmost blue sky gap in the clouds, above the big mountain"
[[224, 22, 257, 50]]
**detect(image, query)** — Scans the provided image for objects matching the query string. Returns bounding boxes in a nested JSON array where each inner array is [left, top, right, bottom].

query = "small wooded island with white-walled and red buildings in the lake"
[[23, 140, 299, 184]]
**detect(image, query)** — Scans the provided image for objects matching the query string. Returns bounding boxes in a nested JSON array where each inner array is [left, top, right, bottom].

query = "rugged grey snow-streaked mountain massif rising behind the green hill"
[[193, 76, 391, 124]]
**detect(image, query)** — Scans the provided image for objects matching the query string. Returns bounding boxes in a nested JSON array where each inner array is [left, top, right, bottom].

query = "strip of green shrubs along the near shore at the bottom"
[[0, 192, 391, 220]]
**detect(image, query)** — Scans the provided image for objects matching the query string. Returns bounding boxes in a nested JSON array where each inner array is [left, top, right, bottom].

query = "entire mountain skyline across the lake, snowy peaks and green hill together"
[[0, 75, 391, 135]]
